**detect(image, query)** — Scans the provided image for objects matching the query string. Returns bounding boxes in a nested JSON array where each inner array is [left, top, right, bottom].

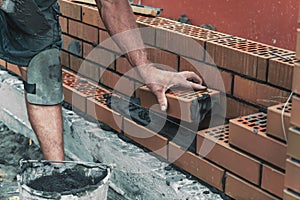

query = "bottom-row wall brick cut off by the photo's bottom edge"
[[225, 173, 279, 200]]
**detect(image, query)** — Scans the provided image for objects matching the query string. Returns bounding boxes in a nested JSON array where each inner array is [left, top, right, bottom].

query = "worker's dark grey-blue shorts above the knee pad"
[[0, 0, 62, 66]]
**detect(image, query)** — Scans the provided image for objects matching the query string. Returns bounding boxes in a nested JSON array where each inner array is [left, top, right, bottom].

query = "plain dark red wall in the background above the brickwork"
[[135, 0, 299, 50]]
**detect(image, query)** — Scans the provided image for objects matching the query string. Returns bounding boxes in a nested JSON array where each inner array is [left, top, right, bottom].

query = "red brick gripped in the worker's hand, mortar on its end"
[[136, 86, 220, 122]]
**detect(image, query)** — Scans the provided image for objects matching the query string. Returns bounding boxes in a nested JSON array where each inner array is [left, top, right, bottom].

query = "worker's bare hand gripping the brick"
[[138, 64, 206, 111]]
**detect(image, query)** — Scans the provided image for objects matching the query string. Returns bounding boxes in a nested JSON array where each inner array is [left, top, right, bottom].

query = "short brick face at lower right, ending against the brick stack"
[[261, 165, 284, 198]]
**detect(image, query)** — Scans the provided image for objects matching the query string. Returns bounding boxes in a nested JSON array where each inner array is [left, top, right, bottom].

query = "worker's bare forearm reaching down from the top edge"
[[96, 0, 149, 66]]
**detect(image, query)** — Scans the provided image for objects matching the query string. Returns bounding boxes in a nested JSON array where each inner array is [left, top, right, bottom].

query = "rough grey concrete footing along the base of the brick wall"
[[0, 67, 228, 200]]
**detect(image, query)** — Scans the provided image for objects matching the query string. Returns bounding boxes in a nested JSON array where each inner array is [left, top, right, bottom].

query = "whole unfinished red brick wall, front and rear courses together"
[[0, 0, 300, 199]]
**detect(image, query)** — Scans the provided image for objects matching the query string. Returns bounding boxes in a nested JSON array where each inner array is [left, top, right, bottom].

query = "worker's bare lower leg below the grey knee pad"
[[20, 50, 64, 160]]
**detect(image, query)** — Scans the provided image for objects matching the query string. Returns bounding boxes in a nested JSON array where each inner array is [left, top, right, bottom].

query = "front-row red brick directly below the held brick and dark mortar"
[[124, 118, 168, 159]]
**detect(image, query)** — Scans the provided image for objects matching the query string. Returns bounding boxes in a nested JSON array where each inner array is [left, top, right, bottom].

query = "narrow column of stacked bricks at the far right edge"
[[284, 5, 300, 200]]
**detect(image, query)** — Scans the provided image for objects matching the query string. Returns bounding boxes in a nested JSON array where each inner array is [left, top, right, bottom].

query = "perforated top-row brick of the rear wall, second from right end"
[[206, 37, 291, 80]]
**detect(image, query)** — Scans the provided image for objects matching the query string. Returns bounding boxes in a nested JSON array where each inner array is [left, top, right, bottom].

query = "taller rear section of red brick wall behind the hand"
[[53, 1, 295, 118]]
